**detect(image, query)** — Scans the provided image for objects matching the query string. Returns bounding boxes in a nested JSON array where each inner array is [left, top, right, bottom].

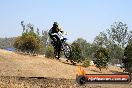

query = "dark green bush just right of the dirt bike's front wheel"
[[68, 42, 84, 64]]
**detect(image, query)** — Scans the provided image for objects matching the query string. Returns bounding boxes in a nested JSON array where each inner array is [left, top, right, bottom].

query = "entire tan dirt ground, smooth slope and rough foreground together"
[[0, 50, 132, 88]]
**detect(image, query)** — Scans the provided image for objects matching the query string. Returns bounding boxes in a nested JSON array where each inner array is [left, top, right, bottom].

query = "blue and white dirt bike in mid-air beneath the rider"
[[51, 32, 71, 59]]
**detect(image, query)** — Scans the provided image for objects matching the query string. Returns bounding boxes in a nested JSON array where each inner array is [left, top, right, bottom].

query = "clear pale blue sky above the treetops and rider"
[[0, 0, 132, 42]]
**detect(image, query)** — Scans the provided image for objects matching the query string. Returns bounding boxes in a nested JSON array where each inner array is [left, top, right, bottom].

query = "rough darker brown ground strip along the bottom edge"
[[0, 77, 132, 88]]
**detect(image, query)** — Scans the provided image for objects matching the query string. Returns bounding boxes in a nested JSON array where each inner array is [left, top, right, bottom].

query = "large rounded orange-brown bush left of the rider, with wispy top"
[[14, 21, 43, 54]]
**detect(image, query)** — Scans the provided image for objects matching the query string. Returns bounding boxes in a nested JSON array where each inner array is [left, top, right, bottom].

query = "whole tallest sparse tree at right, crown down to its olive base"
[[107, 22, 132, 63]]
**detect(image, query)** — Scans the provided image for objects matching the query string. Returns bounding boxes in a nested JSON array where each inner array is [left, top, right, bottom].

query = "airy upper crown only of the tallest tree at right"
[[107, 22, 132, 48]]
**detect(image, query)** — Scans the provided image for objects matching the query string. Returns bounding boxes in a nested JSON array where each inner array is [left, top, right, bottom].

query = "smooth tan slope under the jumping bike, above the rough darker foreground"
[[0, 50, 122, 79]]
